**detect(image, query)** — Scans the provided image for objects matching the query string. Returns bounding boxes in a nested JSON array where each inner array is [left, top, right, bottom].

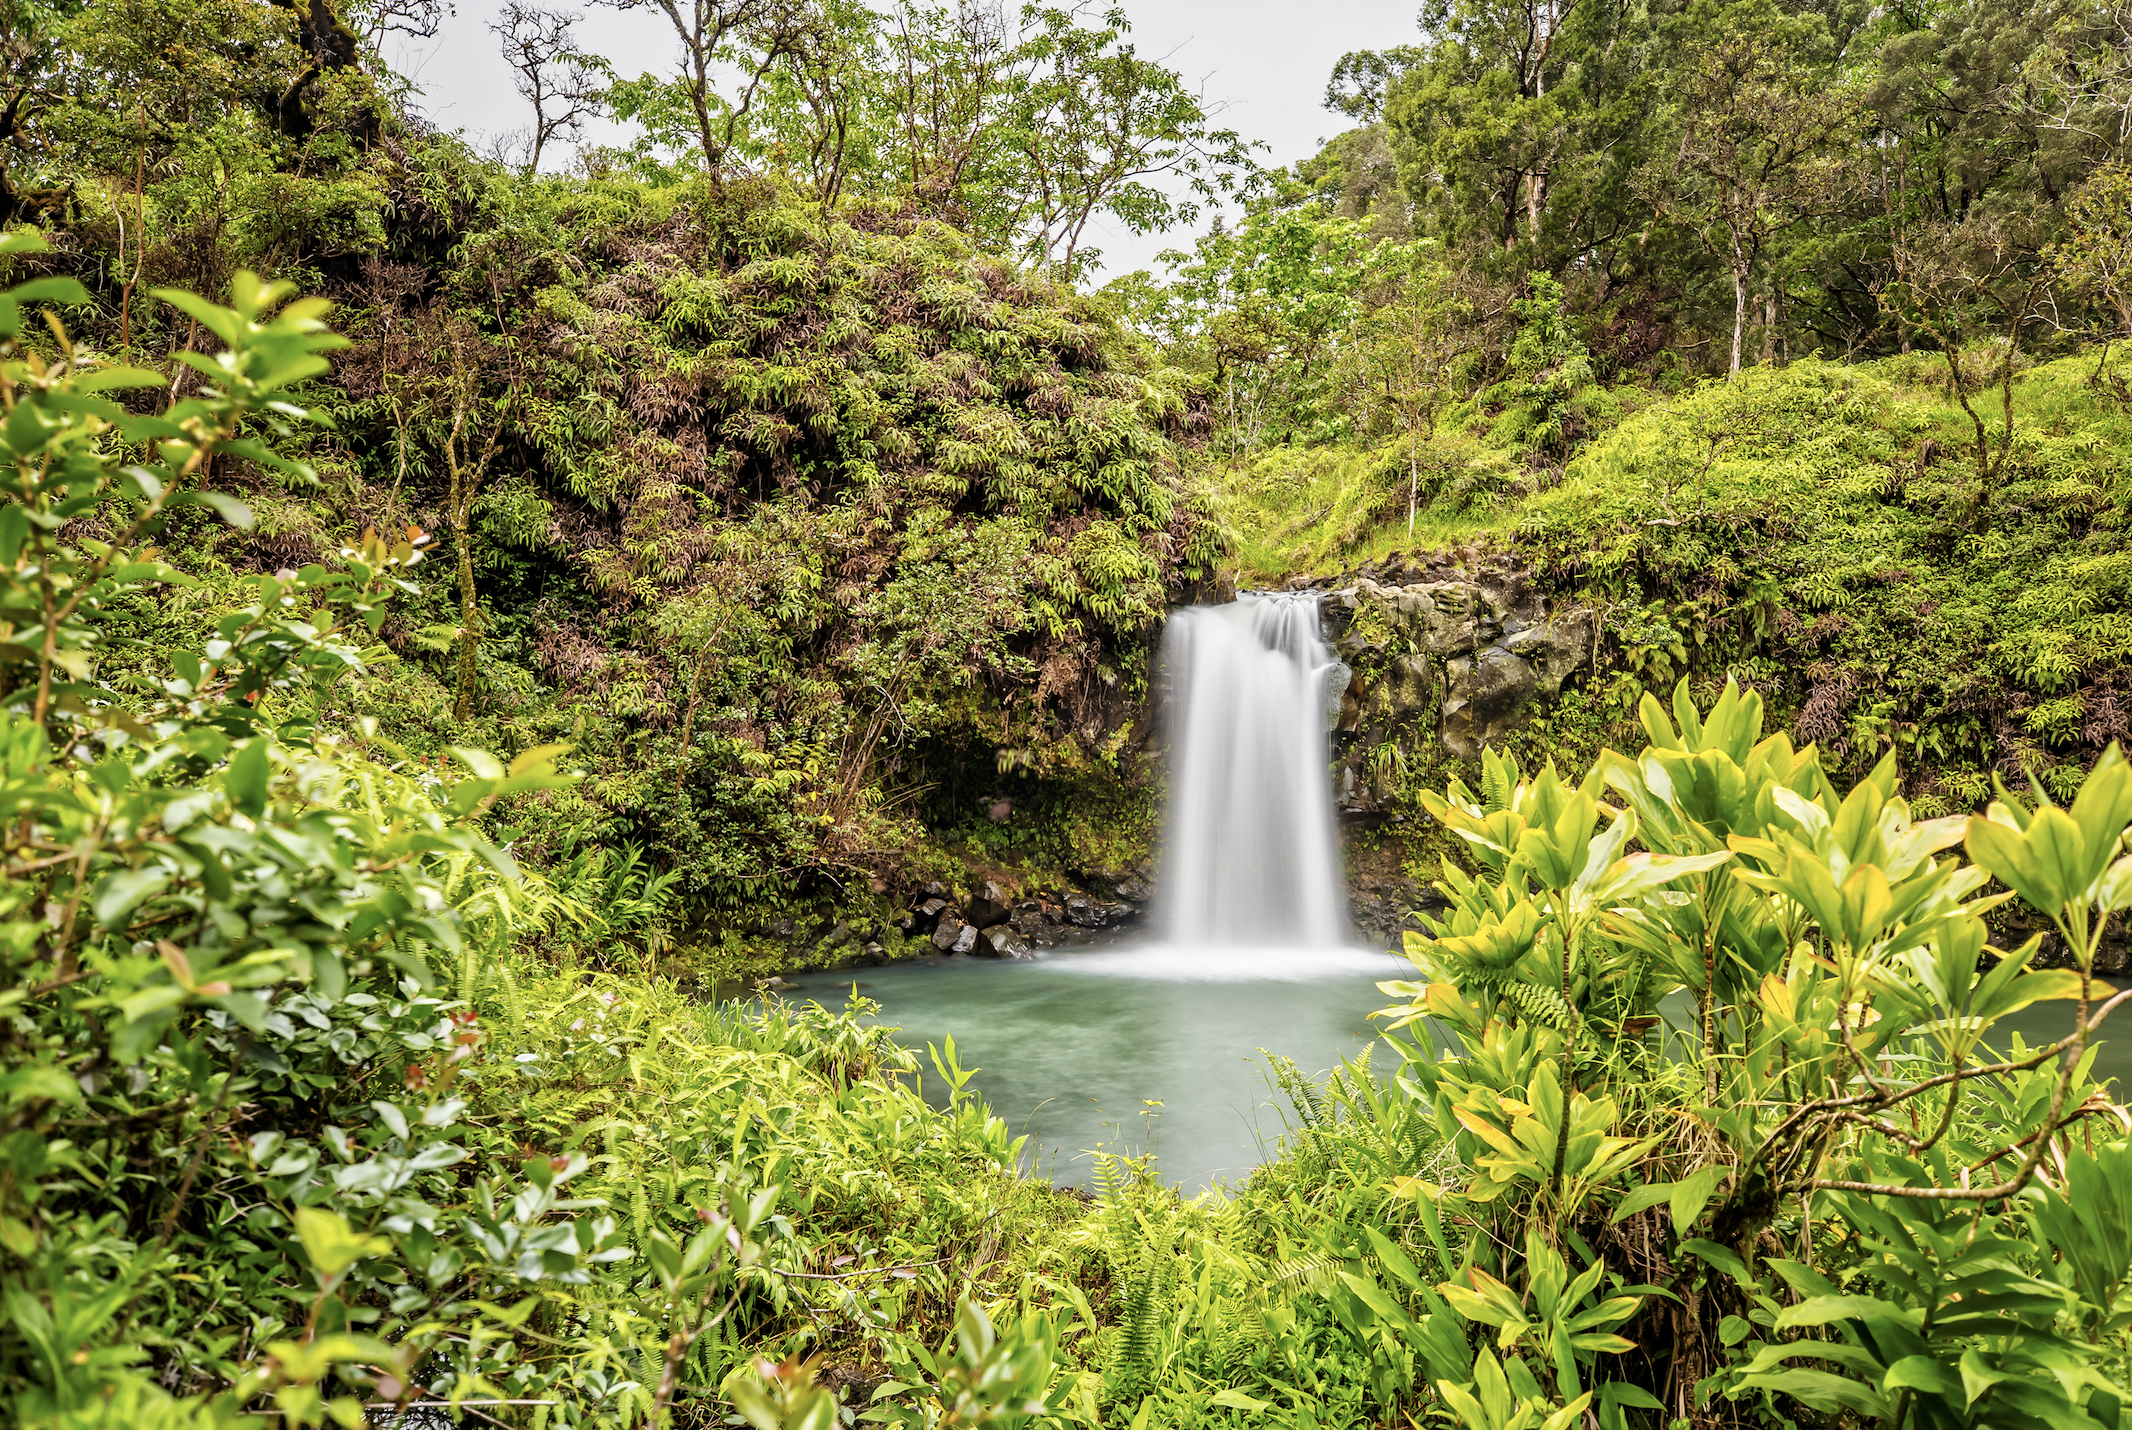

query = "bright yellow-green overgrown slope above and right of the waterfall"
[[1222, 354, 2132, 826]]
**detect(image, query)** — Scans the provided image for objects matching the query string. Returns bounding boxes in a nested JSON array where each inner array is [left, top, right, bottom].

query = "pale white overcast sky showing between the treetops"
[[388, 0, 1414, 275]]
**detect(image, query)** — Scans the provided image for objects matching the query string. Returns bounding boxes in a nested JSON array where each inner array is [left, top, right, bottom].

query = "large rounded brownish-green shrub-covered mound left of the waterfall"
[[366, 188, 1215, 912]]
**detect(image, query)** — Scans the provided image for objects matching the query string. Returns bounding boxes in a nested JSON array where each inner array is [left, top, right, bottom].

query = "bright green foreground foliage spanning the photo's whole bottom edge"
[[0, 260, 2132, 1430]]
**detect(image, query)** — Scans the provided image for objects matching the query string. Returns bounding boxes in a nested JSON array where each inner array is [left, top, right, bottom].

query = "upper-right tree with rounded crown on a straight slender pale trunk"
[[1642, 13, 1855, 373]]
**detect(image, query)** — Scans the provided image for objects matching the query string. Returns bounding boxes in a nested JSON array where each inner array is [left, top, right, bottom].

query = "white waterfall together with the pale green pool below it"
[[797, 592, 1411, 1189]]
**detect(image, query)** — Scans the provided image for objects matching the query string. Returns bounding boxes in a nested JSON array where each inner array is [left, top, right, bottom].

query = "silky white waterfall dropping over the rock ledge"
[[1160, 592, 1347, 948]]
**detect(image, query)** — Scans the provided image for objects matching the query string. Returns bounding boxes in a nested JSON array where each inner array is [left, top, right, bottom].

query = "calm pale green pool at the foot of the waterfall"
[[791, 948, 2132, 1191]]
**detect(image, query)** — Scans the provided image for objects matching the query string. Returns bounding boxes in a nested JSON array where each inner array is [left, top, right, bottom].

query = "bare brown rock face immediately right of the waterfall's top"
[[1311, 558, 1599, 814]]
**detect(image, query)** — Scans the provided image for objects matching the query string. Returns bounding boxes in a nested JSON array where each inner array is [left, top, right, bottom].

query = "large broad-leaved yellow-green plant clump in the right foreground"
[[1382, 686, 2132, 1428]]
